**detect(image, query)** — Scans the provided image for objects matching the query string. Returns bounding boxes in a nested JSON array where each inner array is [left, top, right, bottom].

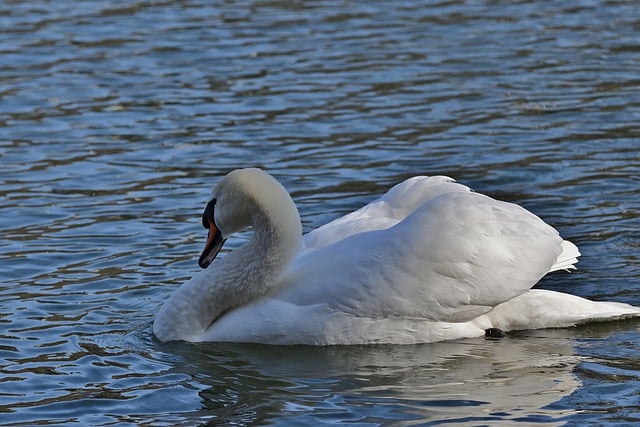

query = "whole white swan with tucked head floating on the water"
[[153, 169, 640, 345]]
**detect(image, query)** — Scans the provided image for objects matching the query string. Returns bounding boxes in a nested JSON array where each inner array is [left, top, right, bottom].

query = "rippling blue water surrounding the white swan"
[[0, 0, 640, 426]]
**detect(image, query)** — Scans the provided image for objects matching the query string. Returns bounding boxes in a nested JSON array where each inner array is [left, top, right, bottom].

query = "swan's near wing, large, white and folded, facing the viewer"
[[281, 192, 563, 322]]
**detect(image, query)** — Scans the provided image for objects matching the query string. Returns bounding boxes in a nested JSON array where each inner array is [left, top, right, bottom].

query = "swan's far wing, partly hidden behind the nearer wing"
[[302, 176, 470, 252]]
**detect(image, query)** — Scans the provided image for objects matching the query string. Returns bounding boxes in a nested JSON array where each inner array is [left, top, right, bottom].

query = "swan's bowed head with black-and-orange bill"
[[198, 168, 301, 268]]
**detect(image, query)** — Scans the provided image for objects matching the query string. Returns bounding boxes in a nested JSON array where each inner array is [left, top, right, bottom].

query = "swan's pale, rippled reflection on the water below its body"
[[160, 329, 616, 425]]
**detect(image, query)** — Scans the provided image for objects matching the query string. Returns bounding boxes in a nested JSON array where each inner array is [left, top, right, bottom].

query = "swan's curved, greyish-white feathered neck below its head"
[[154, 197, 302, 341]]
